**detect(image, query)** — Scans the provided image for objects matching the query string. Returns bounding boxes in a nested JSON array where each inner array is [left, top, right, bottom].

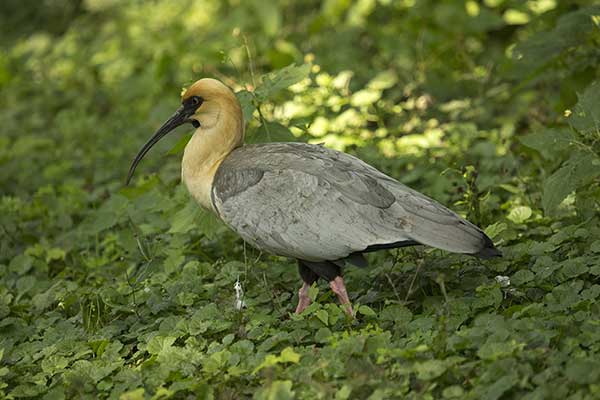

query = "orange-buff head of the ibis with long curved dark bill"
[[126, 78, 243, 184]]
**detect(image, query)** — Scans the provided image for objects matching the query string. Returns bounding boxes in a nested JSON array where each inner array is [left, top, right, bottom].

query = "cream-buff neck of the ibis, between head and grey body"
[[181, 96, 244, 211]]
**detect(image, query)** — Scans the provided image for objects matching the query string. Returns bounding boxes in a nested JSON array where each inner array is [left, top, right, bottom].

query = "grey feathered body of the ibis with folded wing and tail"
[[212, 143, 493, 261]]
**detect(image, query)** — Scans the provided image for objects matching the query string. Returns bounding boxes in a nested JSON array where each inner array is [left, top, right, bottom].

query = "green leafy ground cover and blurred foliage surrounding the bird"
[[0, 0, 600, 399]]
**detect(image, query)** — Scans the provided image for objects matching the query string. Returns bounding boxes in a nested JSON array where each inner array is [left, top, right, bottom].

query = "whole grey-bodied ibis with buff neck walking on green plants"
[[127, 78, 500, 315]]
